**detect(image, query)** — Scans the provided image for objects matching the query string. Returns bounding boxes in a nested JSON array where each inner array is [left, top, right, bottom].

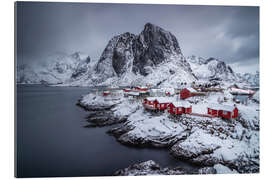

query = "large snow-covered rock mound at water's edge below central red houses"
[[109, 107, 189, 147]]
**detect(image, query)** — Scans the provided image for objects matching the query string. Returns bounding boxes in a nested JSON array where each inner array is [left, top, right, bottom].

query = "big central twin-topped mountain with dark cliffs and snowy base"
[[91, 23, 195, 84]]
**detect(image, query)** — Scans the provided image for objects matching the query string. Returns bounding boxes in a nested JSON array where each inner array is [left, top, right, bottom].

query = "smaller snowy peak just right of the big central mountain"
[[187, 56, 236, 80]]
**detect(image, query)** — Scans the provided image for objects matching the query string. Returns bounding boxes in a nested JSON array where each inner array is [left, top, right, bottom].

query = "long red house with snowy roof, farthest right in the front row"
[[207, 104, 238, 119]]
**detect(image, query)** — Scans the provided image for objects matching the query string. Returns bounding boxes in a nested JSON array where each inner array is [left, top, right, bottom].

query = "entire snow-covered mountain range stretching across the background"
[[17, 23, 259, 87]]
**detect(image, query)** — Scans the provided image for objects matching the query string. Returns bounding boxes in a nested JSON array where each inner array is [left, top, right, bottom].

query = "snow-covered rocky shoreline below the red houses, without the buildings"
[[78, 89, 259, 174]]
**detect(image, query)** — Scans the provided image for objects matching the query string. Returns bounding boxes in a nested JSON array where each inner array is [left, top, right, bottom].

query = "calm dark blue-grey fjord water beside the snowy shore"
[[16, 85, 197, 177]]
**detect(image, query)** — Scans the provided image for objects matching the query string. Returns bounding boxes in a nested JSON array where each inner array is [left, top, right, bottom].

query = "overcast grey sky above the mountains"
[[17, 2, 259, 73]]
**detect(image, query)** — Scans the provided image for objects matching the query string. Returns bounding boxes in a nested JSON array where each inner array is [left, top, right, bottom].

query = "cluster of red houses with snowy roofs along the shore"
[[100, 86, 255, 120]]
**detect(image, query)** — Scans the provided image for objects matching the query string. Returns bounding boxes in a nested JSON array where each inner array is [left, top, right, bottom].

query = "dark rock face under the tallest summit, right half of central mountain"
[[133, 23, 182, 75]]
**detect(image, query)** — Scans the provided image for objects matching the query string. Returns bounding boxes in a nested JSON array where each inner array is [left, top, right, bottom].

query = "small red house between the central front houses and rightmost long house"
[[168, 101, 192, 115]]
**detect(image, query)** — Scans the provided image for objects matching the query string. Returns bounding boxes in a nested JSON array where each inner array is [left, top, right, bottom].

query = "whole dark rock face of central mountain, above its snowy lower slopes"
[[96, 23, 191, 79]]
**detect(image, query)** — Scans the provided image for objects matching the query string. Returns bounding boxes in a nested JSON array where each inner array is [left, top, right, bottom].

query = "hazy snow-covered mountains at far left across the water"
[[17, 52, 91, 84]]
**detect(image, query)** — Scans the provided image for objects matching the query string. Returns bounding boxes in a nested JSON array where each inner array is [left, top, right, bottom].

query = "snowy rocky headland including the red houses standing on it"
[[79, 83, 260, 173]]
